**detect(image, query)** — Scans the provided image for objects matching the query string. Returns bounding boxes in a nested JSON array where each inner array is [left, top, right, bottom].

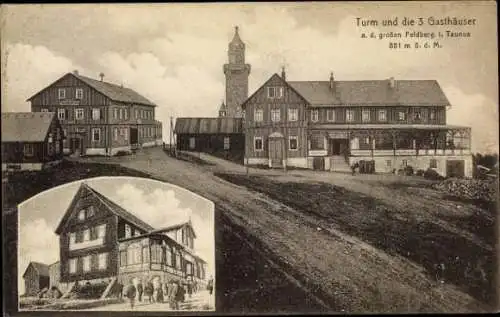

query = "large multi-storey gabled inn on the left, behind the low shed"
[[28, 71, 162, 155]]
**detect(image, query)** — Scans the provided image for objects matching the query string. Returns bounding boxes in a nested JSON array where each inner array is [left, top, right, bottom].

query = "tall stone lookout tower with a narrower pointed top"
[[224, 26, 250, 118]]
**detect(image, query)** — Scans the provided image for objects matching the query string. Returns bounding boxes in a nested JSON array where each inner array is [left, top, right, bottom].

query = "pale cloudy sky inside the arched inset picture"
[[18, 177, 215, 294]]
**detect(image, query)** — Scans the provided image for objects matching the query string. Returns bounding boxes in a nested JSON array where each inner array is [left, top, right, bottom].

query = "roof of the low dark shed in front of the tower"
[[174, 117, 243, 134]]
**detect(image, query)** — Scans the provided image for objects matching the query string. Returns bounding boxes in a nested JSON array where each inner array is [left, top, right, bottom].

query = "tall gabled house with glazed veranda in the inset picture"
[[52, 183, 206, 288]]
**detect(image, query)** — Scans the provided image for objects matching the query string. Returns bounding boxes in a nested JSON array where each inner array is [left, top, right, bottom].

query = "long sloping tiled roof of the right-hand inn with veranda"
[[288, 80, 450, 106]]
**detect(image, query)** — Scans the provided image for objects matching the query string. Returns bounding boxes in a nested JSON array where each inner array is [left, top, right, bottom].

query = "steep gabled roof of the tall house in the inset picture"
[[55, 183, 154, 234]]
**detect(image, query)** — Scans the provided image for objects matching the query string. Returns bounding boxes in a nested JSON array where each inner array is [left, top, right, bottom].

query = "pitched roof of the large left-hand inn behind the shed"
[[28, 73, 156, 106]]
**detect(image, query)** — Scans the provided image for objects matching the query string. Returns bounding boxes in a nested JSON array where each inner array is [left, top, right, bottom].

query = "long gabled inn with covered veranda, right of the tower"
[[242, 70, 472, 177]]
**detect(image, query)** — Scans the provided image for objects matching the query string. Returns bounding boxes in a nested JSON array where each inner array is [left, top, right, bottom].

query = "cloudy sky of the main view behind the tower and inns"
[[2, 1, 498, 152]]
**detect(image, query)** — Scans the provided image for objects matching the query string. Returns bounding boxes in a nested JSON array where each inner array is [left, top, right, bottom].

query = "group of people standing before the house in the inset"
[[119, 279, 213, 310]]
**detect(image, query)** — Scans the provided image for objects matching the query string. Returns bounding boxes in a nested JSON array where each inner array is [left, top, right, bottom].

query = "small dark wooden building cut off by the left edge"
[[2, 112, 63, 171]]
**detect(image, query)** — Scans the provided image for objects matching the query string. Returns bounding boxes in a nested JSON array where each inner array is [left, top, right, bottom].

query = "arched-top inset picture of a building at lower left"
[[18, 177, 215, 311]]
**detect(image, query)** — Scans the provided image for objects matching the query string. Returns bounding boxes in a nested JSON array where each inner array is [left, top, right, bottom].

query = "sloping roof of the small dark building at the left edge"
[[2, 112, 55, 142]]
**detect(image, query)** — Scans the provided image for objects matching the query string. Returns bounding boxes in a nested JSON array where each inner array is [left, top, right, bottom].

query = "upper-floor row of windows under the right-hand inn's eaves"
[[250, 108, 436, 122]]
